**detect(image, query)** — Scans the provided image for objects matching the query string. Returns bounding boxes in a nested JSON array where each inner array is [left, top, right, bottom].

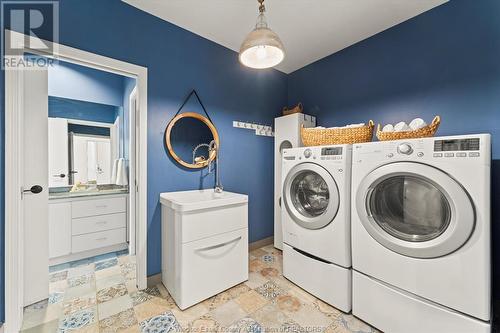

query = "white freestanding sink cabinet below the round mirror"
[[160, 189, 248, 310]]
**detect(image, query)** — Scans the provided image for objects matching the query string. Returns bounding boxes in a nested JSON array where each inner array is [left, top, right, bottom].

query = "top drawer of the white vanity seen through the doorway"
[[71, 197, 127, 218]]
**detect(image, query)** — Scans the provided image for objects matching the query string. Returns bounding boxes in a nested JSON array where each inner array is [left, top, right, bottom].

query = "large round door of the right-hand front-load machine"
[[356, 162, 475, 258]]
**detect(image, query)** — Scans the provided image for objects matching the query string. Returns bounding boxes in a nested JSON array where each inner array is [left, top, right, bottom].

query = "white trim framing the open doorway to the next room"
[[4, 29, 148, 333]]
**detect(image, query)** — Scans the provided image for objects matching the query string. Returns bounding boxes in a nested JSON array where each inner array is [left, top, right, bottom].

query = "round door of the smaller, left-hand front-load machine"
[[283, 163, 340, 229]]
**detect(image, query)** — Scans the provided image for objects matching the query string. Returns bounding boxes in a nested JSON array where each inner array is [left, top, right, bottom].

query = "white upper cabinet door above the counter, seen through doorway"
[[49, 118, 69, 187]]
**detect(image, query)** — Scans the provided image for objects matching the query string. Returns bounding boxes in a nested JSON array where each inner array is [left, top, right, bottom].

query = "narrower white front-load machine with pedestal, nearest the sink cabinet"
[[282, 145, 352, 312]]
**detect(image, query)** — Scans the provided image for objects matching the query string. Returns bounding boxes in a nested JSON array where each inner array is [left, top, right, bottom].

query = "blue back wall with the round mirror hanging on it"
[[0, 0, 287, 319]]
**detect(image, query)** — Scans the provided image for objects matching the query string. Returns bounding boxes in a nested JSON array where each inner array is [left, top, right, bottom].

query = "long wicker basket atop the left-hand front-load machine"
[[300, 120, 375, 146]]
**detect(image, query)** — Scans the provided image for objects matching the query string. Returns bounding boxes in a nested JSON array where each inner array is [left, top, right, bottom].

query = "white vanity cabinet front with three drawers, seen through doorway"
[[49, 194, 128, 264]]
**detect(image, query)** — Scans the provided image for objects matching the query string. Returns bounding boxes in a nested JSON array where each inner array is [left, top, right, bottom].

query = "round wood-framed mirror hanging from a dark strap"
[[165, 112, 219, 169]]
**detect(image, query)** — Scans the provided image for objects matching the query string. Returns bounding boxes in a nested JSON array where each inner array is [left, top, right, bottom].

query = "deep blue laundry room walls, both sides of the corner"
[[0, 0, 500, 319]]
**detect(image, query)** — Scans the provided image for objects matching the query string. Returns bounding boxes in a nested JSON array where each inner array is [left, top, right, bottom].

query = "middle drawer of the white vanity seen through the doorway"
[[71, 213, 127, 236]]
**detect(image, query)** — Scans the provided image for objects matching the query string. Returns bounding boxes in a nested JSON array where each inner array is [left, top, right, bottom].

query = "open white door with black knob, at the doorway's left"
[[21, 64, 49, 305]]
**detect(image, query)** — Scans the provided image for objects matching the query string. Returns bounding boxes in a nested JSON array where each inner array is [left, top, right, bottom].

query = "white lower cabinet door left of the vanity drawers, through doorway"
[[49, 202, 71, 259]]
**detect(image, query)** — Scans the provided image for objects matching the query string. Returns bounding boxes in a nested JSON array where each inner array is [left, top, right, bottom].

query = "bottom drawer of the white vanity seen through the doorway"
[[71, 228, 127, 253]]
